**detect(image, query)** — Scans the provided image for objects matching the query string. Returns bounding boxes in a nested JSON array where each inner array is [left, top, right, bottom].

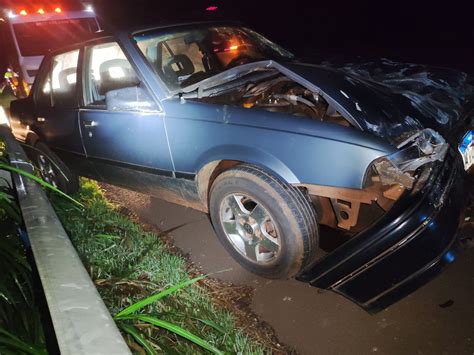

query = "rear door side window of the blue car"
[[50, 50, 79, 107]]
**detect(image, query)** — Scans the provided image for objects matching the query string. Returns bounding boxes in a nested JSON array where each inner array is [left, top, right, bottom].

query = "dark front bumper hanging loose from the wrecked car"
[[297, 152, 463, 312]]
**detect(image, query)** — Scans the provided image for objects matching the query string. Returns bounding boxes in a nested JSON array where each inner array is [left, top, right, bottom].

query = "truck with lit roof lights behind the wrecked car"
[[0, 2, 100, 97]]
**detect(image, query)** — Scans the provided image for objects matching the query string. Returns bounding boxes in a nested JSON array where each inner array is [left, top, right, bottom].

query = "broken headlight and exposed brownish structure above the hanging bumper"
[[298, 128, 449, 238]]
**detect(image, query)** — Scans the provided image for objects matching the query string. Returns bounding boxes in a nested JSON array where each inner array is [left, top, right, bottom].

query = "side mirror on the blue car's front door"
[[105, 86, 160, 112]]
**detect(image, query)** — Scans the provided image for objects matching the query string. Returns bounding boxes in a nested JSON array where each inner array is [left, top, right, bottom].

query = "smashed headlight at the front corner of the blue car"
[[372, 128, 448, 189]]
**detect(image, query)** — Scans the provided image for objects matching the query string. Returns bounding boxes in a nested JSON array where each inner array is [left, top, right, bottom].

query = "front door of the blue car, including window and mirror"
[[79, 42, 173, 190]]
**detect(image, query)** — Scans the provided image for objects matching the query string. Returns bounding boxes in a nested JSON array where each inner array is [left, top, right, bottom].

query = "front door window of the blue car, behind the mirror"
[[84, 42, 159, 111]]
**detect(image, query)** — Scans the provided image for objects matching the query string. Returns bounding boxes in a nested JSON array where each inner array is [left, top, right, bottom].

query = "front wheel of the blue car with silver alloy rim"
[[209, 165, 319, 278]]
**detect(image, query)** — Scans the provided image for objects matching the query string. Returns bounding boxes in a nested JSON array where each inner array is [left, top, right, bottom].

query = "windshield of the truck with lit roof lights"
[[13, 18, 98, 57]]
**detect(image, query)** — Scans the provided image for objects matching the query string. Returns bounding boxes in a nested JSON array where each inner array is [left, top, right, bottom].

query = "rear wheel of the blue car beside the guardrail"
[[31, 142, 79, 195]]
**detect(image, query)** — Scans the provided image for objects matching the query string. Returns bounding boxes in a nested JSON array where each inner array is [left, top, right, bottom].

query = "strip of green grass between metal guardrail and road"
[[53, 180, 270, 354]]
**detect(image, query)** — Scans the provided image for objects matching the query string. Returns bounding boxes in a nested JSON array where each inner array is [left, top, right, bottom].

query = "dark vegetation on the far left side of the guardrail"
[[0, 140, 46, 355]]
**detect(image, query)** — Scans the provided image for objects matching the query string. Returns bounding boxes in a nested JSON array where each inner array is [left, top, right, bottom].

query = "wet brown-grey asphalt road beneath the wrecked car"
[[104, 188, 474, 355]]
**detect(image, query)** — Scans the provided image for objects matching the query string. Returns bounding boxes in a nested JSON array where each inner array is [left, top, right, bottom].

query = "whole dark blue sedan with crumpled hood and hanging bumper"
[[11, 23, 474, 312]]
